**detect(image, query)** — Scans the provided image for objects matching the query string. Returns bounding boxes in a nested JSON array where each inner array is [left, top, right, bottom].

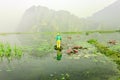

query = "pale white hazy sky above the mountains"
[[0, 0, 117, 32]]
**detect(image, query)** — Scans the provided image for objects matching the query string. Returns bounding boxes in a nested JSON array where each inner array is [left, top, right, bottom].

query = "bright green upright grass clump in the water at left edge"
[[0, 42, 23, 61]]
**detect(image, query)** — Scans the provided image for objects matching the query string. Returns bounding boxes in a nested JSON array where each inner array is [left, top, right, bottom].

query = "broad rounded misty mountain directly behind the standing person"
[[18, 6, 84, 32]]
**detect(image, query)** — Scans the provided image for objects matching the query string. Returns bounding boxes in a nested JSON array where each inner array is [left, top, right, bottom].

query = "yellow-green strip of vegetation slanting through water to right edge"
[[87, 39, 120, 70]]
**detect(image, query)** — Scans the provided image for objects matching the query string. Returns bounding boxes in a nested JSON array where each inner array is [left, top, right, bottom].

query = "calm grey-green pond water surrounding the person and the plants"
[[0, 33, 120, 80]]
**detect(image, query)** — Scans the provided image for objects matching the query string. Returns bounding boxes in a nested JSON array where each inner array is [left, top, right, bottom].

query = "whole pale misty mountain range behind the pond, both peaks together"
[[18, 0, 120, 32]]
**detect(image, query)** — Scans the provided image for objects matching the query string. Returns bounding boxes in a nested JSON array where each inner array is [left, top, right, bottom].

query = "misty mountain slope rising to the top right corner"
[[88, 0, 120, 29]]
